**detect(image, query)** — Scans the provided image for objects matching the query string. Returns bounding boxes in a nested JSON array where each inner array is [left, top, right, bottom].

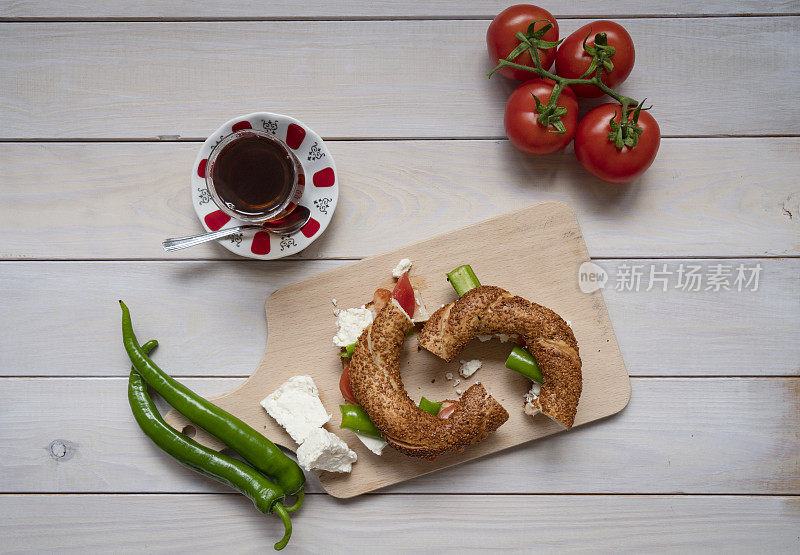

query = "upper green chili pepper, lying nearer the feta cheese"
[[119, 301, 305, 502]]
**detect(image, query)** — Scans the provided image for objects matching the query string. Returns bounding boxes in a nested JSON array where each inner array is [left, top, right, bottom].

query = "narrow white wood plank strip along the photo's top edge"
[[0, 0, 800, 20]]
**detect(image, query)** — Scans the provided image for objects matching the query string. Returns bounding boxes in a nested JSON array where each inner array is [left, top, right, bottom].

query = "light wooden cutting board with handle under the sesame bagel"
[[166, 202, 631, 498]]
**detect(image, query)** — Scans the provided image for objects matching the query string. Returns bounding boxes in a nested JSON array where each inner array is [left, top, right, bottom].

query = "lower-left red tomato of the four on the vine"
[[505, 79, 578, 154]]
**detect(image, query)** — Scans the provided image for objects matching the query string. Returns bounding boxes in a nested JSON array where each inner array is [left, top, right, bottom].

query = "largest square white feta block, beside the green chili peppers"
[[261, 376, 331, 443]]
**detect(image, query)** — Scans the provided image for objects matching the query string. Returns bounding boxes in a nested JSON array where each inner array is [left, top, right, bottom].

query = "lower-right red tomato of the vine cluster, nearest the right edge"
[[575, 103, 661, 183]]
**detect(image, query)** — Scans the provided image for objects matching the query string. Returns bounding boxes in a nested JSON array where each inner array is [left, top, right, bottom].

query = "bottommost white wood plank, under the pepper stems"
[[0, 495, 800, 553]]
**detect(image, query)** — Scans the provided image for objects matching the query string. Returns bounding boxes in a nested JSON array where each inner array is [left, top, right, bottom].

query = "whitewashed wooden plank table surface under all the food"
[[0, 0, 800, 553]]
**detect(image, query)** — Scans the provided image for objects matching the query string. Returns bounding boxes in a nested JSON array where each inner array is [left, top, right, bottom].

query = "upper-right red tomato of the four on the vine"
[[556, 20, 636, 98]]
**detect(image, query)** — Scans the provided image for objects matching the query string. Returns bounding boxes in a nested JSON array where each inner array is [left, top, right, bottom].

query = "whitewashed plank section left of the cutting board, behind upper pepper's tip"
[[0, 261, 343, 376]]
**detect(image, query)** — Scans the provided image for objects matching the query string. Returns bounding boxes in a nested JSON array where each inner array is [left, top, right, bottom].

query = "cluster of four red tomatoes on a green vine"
[[486, 4, 661, 183]]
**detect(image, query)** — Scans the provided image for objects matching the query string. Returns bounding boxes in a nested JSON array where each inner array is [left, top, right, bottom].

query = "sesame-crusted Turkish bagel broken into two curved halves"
[[349, 286, 581, 458]]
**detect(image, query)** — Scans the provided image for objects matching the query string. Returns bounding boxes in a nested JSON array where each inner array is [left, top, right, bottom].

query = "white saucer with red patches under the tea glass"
[[192, 112, 339, 260]]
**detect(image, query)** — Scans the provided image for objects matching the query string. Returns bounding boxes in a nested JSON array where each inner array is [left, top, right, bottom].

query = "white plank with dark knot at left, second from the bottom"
[[0, 378, 800, 494]]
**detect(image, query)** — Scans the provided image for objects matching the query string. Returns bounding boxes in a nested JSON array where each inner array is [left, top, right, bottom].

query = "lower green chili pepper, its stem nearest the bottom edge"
[[128, 341, 292, 550]]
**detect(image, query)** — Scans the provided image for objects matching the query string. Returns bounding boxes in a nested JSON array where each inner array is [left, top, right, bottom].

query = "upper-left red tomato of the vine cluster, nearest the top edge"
[[486, 4, 558, 81]]
